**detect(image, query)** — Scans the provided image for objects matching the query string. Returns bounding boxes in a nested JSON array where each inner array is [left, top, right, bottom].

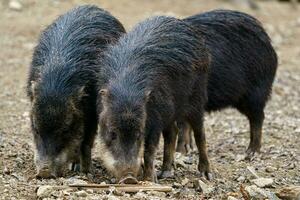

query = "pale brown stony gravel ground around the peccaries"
[[0, 0, 300, 200]]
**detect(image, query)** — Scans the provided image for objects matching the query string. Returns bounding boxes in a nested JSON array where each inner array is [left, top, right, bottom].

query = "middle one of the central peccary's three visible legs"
[[159, 124, 178, 178]]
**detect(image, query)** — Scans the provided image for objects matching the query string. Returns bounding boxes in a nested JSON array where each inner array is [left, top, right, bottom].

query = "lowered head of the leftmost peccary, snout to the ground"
[[30, 82, 84, 178]]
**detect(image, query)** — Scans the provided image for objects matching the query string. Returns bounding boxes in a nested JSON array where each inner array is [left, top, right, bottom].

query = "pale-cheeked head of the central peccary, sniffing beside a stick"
[[99, 88, 150, 183]]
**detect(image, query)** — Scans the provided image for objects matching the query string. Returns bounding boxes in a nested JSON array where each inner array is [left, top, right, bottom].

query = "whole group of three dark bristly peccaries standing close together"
[[27, 5, 277, 184]]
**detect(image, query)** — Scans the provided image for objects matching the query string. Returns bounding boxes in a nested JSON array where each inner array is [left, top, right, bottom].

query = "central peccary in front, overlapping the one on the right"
[[98, 16, 210, 183]]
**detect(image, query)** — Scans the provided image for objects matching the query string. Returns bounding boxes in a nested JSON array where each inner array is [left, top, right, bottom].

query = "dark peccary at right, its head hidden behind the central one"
[[177, 10, 277, 159]]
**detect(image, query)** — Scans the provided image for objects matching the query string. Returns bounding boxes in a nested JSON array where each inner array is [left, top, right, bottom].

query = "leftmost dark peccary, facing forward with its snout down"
[[27, 5, 125, 178]]
